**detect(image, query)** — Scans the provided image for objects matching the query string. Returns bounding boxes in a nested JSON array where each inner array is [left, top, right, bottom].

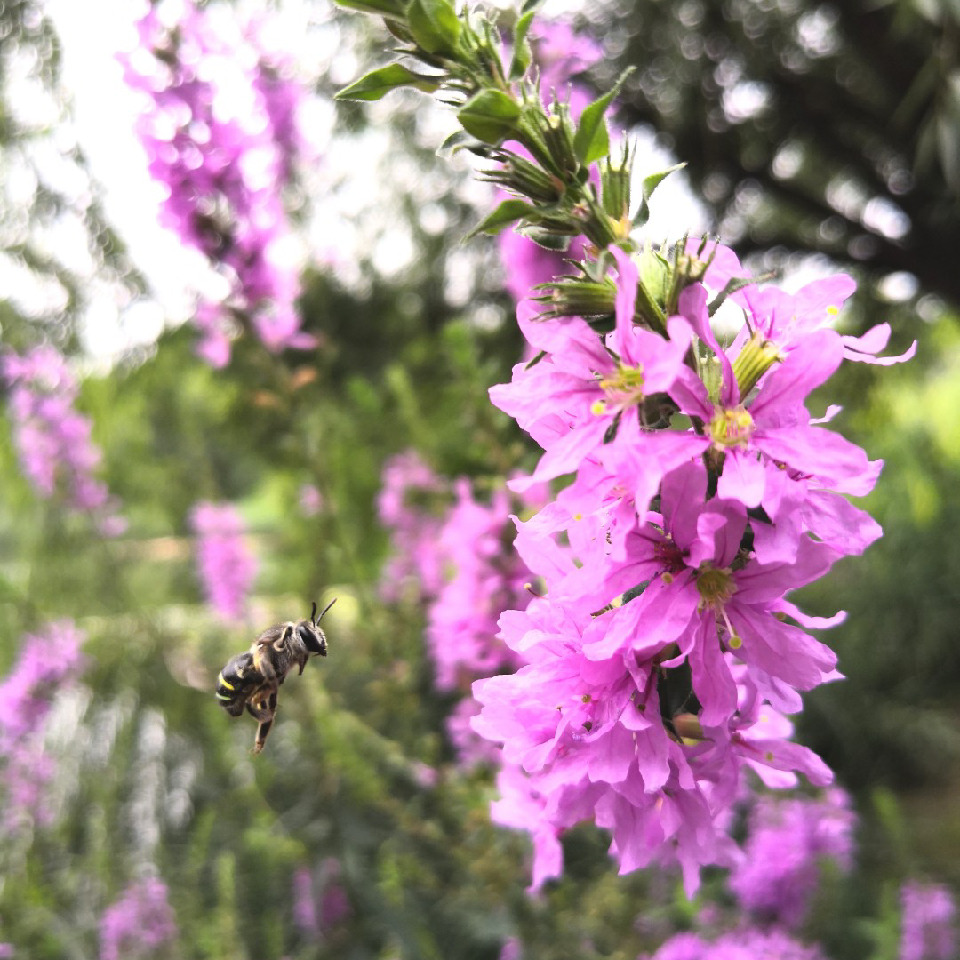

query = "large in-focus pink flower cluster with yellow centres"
[[473, 244, 916, 891]]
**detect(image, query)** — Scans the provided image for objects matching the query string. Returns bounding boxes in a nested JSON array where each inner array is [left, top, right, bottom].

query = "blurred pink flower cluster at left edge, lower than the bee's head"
[[0, 620, 84, 830]]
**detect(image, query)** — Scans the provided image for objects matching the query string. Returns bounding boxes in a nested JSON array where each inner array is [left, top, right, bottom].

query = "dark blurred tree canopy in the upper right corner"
[[587, 0, 960, 303]]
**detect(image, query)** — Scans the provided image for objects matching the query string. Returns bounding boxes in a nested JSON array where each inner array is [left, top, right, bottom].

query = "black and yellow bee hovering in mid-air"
[[217, 597, 337, 753]]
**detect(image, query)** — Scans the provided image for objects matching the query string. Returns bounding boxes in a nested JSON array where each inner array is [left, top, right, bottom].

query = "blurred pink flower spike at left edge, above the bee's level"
[[2, 344, 124, 536]]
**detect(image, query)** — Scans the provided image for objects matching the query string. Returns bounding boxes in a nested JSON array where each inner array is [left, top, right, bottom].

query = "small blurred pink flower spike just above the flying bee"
[[190, 502, 257, 620]]
